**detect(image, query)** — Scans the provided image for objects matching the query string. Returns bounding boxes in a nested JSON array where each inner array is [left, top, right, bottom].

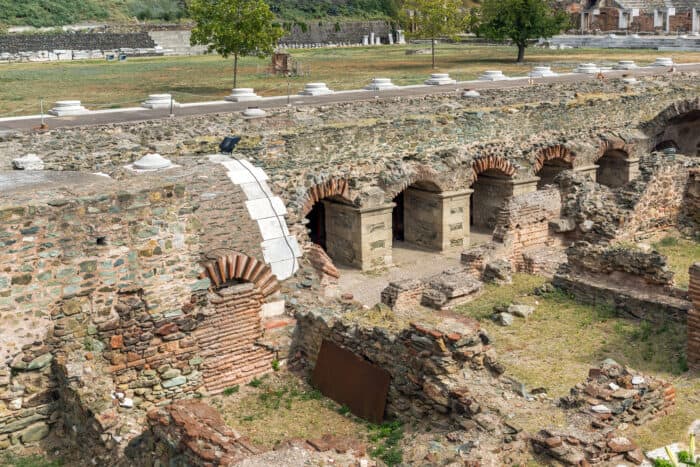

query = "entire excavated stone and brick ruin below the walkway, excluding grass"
[[0, 74, 700, 466]]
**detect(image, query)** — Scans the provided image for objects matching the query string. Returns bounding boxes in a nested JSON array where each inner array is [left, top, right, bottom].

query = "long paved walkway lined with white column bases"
[[0, 63, 700, 131]]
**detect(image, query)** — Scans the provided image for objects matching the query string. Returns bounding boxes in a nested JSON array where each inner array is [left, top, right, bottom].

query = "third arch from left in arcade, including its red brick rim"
[[469, 156, 516, 235]]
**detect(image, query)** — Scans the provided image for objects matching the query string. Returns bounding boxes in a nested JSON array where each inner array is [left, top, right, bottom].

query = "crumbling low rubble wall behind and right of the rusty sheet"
[[294, 310, 503, 425]]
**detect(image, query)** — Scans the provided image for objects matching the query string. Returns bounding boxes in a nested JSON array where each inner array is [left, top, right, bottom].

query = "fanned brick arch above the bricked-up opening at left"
[[199, 250, 280, 298]]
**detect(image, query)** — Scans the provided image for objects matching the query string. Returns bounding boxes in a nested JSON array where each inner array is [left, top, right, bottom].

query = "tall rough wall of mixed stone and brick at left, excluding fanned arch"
[[0, 165, 272, 446]]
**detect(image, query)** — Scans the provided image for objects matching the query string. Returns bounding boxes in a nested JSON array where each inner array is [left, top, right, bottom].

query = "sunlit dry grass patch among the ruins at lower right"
[[457, 274, 700, 448]]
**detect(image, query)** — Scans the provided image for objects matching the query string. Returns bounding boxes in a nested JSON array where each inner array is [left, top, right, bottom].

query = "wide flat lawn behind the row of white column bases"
[[0, 44, 700, 116]]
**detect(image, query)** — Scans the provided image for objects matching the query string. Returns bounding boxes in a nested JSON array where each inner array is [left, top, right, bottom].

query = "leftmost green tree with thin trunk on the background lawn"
[[188, 0, 284, 88]]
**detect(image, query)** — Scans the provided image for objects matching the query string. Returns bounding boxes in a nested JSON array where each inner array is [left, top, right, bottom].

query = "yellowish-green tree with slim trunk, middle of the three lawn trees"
[[401, 0, 465, 68]]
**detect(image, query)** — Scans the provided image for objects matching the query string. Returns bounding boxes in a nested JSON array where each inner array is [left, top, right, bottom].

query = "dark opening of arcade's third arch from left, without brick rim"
[[469, 169, 513, 239]]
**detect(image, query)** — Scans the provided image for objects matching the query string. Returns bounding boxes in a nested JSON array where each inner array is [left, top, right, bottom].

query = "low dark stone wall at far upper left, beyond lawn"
[[0, 32, 156, 53]]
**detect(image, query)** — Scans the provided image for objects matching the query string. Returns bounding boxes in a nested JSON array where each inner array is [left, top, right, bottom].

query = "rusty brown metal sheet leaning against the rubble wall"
[[311, 339, 391, 423]]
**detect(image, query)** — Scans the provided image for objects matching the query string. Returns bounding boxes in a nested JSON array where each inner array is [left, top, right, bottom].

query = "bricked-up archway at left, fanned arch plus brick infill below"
[[192, 251, 279, 393]]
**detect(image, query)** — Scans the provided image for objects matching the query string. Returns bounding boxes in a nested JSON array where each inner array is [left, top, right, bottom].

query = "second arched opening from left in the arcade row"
[[391, 181, 444, 250]]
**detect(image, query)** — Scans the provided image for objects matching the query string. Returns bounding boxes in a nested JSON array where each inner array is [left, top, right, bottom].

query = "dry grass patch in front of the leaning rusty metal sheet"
[[209, 371, 367, 448]]
